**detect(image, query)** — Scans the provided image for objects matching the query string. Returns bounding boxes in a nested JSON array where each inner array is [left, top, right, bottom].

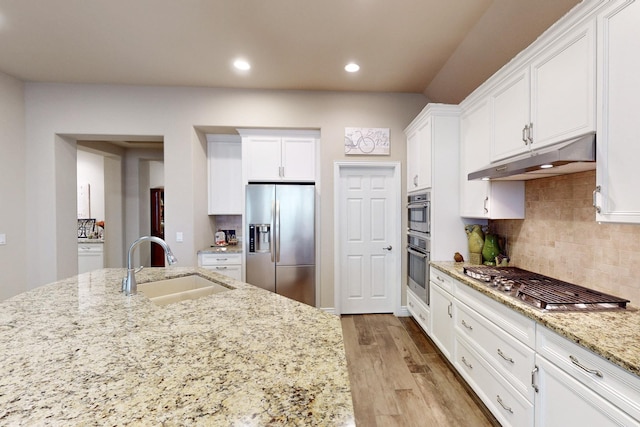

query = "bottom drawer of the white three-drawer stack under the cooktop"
[[455, 338, 534, 427]]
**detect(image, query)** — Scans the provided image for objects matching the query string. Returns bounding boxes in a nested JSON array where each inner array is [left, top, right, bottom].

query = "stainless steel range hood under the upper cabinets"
[[468, 133, 596, 181]]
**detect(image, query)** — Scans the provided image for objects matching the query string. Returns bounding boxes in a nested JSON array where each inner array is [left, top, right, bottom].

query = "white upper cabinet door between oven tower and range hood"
[[460, 98, 491, 218]]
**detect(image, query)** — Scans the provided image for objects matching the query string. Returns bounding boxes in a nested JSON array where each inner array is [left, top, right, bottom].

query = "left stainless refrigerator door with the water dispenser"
[[245, 184, 276, 292]]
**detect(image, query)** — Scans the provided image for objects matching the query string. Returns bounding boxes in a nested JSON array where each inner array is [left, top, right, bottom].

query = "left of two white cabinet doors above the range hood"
[[489, 67, 530, 161]]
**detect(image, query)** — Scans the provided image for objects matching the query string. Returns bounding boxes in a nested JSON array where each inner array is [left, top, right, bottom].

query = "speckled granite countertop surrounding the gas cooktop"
[[431, 261, 640, 376]]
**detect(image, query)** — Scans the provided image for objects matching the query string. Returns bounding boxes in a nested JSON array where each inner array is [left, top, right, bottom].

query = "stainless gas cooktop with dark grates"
[[464, 266, 629, 311]]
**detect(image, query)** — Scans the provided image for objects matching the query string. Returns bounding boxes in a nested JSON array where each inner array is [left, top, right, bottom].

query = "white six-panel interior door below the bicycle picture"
[[335, 163, 401, 314]]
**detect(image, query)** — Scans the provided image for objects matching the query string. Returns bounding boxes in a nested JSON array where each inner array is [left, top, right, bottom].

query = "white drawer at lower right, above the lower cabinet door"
[[536, 328, 640, 421]]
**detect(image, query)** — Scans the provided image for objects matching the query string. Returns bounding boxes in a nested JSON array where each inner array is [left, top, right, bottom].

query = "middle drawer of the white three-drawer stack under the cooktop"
[[455, 301, 535, 402]]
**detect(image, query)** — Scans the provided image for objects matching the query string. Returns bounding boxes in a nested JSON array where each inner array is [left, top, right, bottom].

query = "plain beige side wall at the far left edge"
[[0, 73, 26, 300]]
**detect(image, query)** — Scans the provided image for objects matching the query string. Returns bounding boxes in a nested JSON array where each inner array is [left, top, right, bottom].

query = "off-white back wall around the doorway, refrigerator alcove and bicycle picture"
[[25, 83, 426, 307]]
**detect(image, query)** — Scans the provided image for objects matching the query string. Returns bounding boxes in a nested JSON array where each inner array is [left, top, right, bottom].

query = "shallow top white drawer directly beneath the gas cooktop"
[[456, 283, 536, 348]]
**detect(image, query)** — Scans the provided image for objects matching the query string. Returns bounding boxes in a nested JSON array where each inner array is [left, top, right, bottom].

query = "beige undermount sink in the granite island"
[[138, 274, 231, 305]]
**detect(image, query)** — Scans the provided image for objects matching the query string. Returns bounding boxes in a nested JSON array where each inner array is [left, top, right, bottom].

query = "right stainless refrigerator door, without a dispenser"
[[274, 185, 316, 306]]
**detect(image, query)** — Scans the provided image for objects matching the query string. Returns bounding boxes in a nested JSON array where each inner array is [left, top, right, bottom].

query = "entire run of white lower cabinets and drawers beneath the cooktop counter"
[[422, 268, 640, 427]]
